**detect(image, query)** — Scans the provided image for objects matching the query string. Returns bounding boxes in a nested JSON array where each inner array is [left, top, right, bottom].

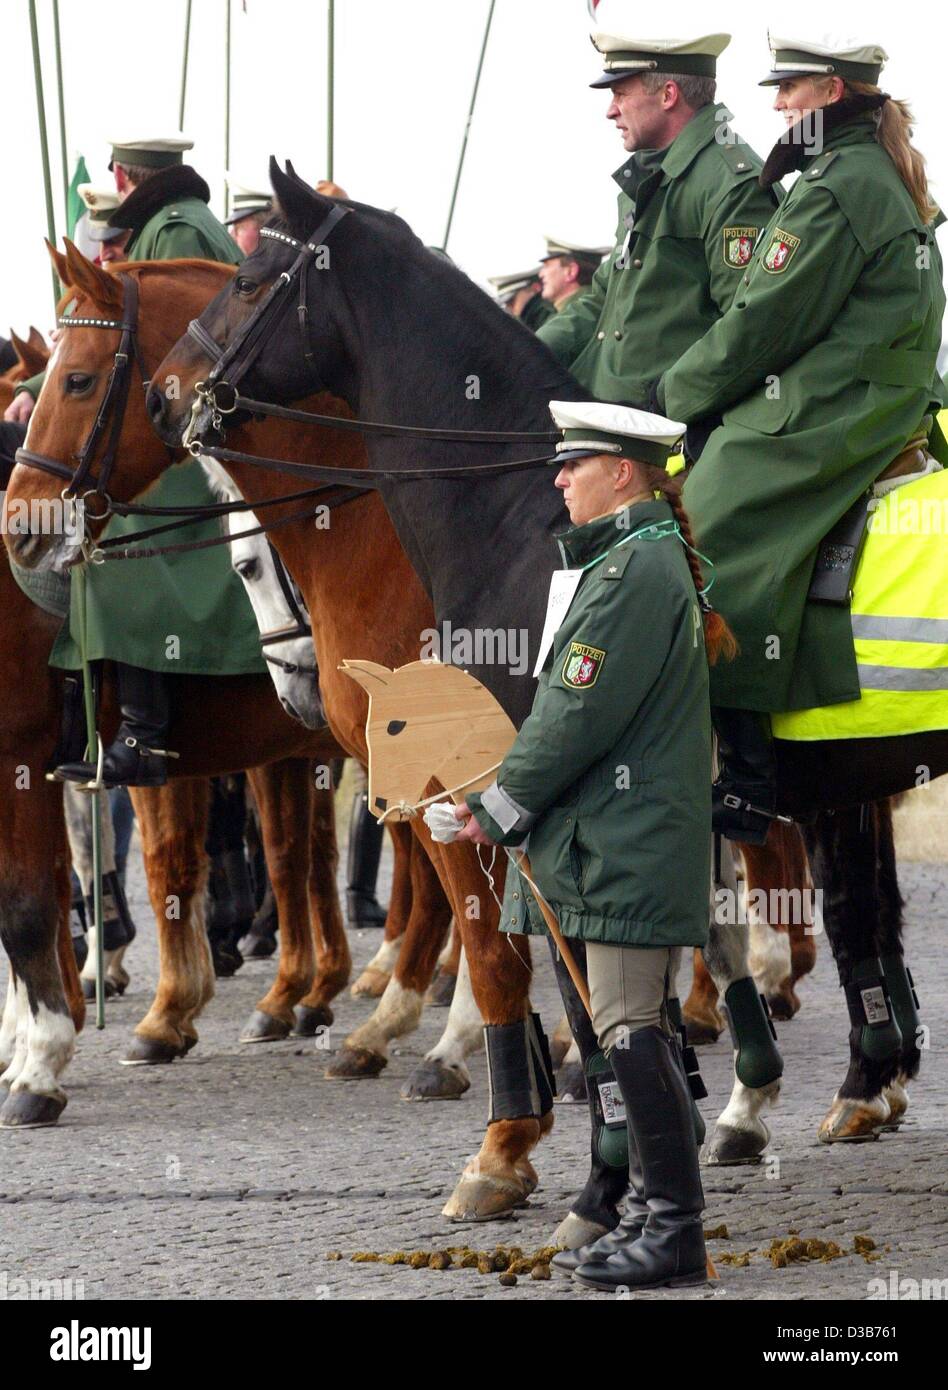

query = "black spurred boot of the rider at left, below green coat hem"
[[56, 663, 171, 788]]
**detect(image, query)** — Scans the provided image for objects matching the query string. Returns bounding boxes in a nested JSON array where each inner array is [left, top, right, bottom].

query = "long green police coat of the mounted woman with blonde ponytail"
[[659, 115, 948, 712]]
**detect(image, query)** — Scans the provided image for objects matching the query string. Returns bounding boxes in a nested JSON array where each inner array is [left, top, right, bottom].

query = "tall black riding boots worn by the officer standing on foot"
[[573, 1027, 708, 1291]]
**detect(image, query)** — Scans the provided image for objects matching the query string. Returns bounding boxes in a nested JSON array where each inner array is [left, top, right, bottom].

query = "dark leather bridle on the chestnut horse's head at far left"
[[15, 274, 150, 520]]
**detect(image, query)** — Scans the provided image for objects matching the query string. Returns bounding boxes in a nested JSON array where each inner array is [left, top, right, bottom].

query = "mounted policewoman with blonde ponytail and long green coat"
[[656, 36, 948, 841]]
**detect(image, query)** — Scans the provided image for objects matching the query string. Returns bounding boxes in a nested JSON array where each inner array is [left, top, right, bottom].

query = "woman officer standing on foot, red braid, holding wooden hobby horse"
[[456, 402, 726, 1289]]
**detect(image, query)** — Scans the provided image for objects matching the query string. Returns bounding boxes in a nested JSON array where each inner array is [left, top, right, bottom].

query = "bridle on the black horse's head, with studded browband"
[[182, 203, 349, 436]]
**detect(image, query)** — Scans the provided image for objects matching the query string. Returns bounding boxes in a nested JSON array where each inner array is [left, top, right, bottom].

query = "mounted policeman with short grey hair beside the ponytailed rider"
[[538, 25, 778, 417]]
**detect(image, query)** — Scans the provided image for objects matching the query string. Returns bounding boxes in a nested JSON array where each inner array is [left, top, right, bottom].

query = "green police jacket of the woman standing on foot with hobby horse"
[[467, 500, 712, 947]]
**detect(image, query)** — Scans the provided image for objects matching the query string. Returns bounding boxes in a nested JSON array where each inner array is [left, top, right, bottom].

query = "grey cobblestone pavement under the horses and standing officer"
[[0, 822, 948, 1300]]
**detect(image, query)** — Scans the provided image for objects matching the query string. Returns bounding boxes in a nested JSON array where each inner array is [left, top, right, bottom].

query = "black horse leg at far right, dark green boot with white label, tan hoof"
[[806, 806, 902, 1144]]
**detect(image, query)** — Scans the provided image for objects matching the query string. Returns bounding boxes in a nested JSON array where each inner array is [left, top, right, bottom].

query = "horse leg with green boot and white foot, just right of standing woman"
[[703, 842, 783, 1165]]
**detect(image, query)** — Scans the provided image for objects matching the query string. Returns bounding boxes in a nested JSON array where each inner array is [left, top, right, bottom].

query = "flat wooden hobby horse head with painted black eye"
[[339, 660, 514, 820]]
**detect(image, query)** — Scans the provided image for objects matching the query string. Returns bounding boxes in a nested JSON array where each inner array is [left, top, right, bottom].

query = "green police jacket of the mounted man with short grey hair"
[[537, 104, 778, 404]]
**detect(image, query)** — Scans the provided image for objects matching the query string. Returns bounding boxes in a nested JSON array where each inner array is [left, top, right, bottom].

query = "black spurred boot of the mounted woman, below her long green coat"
[[712, 705, 777, 845]]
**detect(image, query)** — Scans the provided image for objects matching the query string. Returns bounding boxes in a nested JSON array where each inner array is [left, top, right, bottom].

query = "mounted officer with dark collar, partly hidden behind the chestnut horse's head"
[[51, 135, 254, 787]]
